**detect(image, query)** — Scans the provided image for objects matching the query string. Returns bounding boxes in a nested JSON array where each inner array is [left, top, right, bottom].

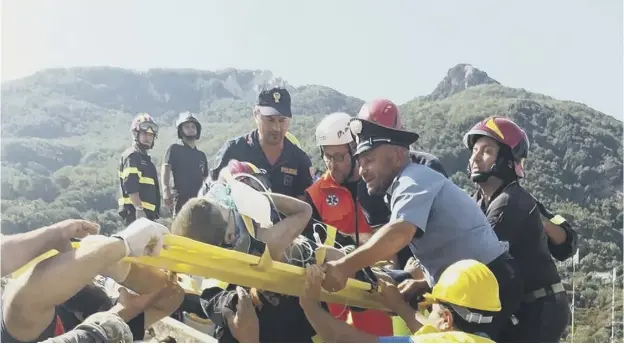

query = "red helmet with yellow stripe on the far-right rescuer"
[[464, 116, 529, 178]]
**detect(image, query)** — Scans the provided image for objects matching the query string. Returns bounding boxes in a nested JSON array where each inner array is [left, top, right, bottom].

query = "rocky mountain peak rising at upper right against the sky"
[[425, 63, 500, 100]]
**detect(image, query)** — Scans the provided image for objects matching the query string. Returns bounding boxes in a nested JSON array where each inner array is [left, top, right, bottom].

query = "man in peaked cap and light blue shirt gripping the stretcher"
[[323, 119, 522, 340]]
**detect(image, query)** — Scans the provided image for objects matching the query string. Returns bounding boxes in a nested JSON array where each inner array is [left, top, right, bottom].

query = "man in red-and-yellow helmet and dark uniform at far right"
[[464, 117, 576, 343]]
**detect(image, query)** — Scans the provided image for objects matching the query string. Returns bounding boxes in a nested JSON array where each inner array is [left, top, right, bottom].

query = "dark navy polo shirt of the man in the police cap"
[[210, 130, 312, 197]]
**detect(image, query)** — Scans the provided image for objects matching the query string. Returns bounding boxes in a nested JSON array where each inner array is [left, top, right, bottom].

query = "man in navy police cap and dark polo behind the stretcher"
[[210, 87, 312, 199]]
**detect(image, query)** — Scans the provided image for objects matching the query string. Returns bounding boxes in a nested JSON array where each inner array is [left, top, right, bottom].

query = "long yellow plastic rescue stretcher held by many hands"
[[13, 235, 386, 310]]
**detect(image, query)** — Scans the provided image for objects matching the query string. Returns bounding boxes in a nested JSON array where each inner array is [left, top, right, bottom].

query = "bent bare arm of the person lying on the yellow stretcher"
[[258, 193, 312, 260]]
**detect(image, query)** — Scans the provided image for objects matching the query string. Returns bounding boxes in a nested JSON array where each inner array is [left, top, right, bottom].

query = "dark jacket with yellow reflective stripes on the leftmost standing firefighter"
[[119, 145, 160, 225]]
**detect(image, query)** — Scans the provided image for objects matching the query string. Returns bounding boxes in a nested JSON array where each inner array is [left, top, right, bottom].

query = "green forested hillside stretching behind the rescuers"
[[1, 65, 623, 342]]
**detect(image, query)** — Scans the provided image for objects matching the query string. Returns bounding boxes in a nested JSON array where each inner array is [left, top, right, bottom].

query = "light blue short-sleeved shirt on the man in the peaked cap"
[[387, 163, 508, 283]]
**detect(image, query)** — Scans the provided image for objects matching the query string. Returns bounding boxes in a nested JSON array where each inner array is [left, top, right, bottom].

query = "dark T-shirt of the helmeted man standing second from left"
[[164, 143, 208, 214]]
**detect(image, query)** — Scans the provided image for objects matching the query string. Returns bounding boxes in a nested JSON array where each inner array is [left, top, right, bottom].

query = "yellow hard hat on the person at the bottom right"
[[423, 259, 501, 312]]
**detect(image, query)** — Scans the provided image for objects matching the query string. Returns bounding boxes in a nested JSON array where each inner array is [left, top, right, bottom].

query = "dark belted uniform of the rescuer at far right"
[[475, 181, 570, 343]]
